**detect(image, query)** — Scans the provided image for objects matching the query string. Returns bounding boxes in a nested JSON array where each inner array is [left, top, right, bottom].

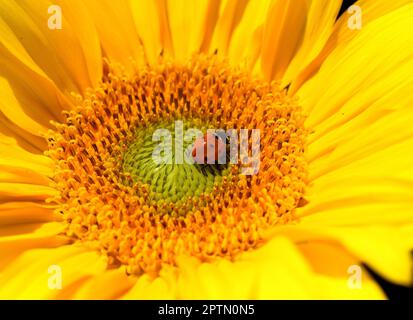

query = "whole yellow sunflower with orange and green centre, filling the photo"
[[0, 0, 413, 299]]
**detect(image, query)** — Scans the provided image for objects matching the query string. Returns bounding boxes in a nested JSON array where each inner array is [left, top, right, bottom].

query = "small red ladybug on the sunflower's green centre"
[[191, 133, 227, 164]]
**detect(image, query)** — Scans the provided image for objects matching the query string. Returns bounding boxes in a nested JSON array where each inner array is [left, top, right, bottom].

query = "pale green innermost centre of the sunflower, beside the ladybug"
[[123, 119, 229, 203]]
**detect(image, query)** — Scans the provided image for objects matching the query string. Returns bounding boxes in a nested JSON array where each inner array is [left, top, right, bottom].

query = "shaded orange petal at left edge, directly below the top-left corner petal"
[[0, 2, 73, 135]]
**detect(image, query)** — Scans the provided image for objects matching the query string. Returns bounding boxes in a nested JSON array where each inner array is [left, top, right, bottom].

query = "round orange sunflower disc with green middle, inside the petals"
[[47, 56, 306, 274]]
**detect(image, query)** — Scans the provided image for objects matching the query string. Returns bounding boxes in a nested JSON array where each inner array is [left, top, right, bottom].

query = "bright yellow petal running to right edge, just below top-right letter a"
[[298, 9, 413, 127]]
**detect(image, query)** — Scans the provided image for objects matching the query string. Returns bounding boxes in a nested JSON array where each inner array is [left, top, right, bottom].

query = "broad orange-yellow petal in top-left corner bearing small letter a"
[[1, 0, 102, 92]]
